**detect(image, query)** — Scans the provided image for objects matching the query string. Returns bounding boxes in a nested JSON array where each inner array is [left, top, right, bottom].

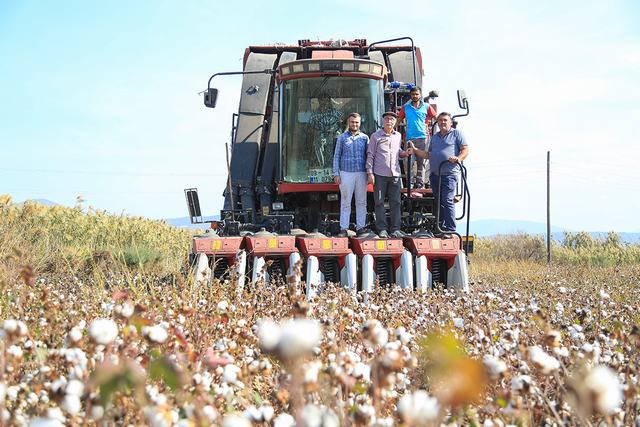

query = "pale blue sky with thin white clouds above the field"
[[0, 0, 640, 231]]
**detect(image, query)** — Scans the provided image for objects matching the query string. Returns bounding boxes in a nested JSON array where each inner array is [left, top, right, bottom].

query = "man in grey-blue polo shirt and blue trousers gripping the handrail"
[[407, 112, 469, 233]]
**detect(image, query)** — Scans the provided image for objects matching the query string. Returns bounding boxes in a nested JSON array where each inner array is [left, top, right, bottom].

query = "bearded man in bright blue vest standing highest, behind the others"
[[398, 86, 436, 188]]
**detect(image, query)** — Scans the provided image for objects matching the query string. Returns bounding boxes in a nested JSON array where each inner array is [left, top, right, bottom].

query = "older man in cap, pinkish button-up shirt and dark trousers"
[[366, 111, 409, 239]]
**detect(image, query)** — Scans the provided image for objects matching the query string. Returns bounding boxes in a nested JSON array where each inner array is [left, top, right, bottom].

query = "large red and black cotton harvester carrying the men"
[[185, 37, 470, 296]]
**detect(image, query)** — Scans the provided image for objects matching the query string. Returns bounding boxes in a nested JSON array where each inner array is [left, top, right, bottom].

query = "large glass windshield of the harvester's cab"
[[281, 76, 383, 183]]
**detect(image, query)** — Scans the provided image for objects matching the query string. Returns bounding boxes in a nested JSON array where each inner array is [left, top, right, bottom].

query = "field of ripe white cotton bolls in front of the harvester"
[[0, 269, 640, 427]]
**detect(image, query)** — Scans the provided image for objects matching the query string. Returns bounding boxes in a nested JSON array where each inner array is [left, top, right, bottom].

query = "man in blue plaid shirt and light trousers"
[[333, 113, 369, 237]]
